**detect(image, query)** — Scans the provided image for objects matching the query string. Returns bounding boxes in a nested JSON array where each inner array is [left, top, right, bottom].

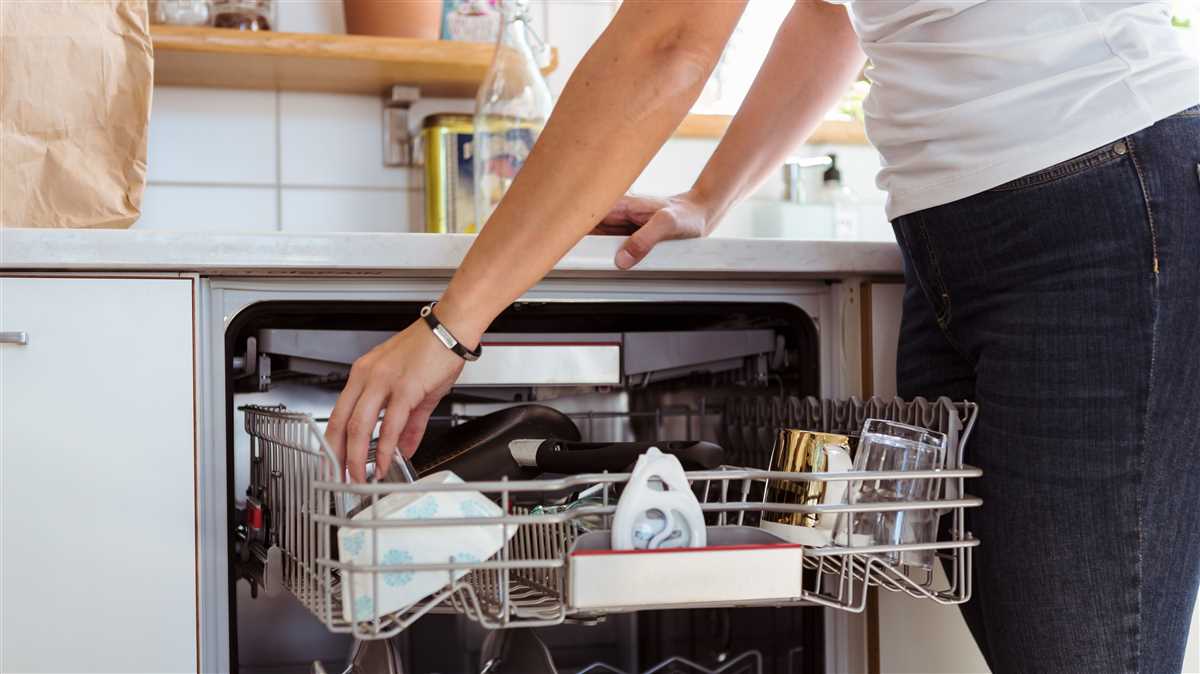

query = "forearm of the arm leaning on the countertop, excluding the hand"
[[691, 0, 865, 225]]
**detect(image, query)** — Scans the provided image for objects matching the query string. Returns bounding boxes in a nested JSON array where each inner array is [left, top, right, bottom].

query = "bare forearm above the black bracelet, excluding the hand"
[[438, 0, 744, 344]]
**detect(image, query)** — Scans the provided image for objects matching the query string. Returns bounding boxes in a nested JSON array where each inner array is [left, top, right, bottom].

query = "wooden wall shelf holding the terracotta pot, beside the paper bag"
[[151, 25, 558, 97]]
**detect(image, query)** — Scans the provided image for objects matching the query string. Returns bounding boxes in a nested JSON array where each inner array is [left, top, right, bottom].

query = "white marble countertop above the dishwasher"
[[0, 229, 901, 278]]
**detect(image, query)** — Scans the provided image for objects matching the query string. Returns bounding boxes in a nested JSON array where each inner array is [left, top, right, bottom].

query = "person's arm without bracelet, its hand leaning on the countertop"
[[605, 0, 865, 269]]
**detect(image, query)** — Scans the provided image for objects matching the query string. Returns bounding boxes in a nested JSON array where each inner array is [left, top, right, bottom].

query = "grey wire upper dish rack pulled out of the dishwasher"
[[241, 396, 982, 639]]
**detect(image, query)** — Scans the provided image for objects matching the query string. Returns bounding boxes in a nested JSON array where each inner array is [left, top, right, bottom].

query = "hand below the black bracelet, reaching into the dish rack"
[[325, 321, 463, 482]]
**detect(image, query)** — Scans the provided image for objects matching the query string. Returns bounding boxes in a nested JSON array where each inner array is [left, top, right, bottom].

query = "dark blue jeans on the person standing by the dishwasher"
[[893, 107, 1200, 674]]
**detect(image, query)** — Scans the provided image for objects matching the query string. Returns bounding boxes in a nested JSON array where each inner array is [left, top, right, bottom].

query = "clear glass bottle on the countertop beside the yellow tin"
[[472, 0, 553, 231]]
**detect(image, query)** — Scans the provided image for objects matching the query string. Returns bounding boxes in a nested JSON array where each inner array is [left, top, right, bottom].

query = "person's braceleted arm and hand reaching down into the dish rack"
[[325, 0, 745, 480]]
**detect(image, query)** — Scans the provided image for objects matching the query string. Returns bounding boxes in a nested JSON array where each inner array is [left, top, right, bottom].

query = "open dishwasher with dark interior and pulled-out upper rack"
[[216, 283, 978, 674]]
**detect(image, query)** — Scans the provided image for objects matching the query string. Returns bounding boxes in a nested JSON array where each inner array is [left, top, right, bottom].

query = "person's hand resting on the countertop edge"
[[593, 192, 715, 269]]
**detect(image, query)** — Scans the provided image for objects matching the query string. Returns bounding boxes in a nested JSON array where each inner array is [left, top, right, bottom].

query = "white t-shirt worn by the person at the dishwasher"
[[832, 0, 1200, 218]]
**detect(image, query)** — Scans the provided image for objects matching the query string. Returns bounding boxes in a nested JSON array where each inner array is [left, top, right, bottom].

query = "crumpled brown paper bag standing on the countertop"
[[0, 0, 154, 228]]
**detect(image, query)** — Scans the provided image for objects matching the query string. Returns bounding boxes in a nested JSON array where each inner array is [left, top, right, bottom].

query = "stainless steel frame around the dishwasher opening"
[[197, 275, 865, 673]]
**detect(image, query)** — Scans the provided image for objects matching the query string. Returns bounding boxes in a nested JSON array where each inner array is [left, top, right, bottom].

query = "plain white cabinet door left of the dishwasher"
[[0, 278, 197, 673]]
